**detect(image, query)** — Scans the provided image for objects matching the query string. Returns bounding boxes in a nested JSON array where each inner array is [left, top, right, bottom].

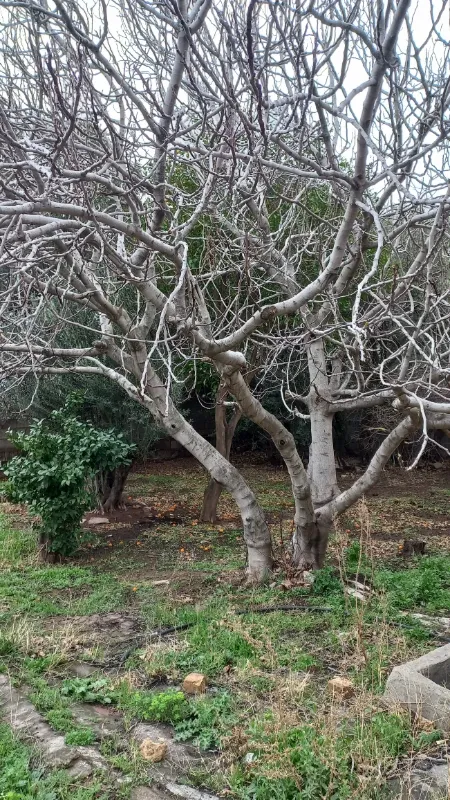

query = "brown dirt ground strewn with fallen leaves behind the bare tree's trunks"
[[76, 458, 450, 583]]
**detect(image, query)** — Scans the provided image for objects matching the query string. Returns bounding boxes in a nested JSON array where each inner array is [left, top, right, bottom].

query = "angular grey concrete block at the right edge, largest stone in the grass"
[[384, 644, 450, 731]]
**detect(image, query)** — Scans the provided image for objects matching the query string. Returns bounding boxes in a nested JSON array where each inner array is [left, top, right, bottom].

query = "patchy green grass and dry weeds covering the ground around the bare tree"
[[0, 468, 450, 800]]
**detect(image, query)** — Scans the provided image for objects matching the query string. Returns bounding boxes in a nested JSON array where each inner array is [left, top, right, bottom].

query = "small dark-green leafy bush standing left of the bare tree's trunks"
[[4, 400, 133, 556]]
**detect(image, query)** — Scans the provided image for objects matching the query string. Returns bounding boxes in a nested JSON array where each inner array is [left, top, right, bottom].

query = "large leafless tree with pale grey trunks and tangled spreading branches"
[[0, 0, 450, 579]]
